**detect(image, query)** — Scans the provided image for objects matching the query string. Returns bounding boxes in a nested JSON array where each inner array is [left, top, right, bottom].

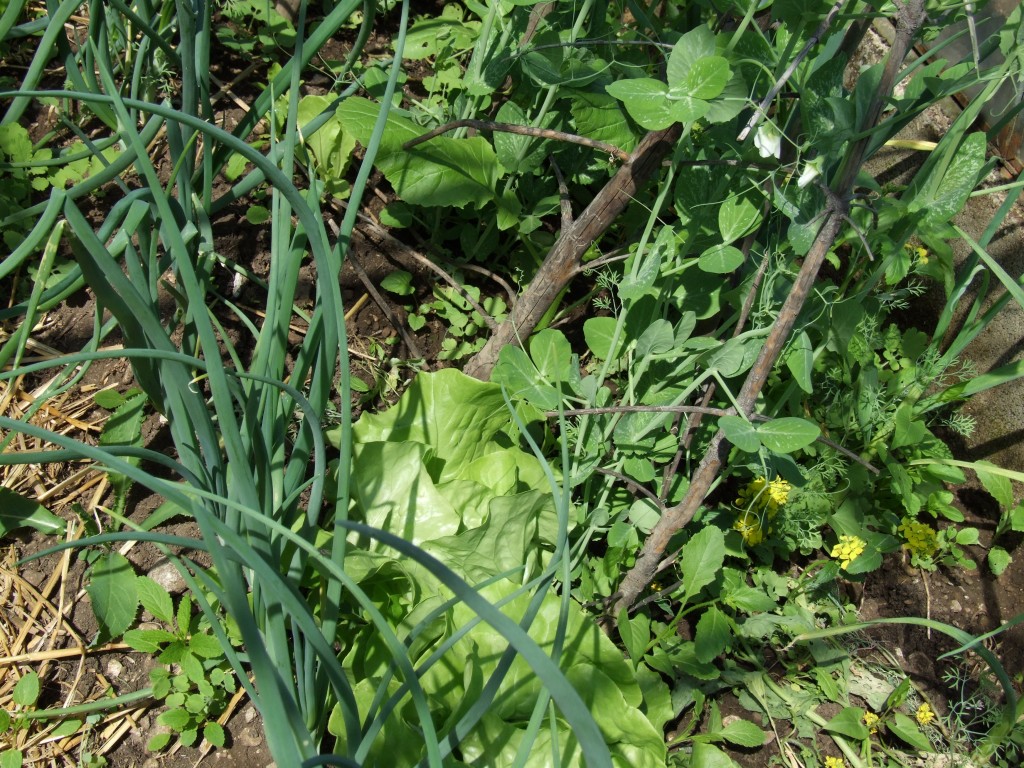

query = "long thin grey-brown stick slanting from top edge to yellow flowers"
[[607, 0, 925, 615]]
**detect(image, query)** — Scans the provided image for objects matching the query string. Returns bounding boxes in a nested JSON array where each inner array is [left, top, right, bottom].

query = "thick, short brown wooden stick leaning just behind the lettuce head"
[[465, 123, 682, 381]]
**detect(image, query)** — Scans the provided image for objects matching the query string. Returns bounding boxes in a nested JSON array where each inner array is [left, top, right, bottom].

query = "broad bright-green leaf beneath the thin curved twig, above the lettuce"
[[338, 96, 500, 207]]
